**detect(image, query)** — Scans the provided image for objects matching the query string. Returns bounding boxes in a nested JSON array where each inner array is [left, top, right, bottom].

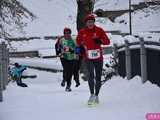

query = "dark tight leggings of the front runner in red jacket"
[[86, 60, 103, 96]]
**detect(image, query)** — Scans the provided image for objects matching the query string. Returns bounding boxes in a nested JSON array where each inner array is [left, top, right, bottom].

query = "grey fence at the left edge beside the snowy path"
[[0, 42, 9, 102]]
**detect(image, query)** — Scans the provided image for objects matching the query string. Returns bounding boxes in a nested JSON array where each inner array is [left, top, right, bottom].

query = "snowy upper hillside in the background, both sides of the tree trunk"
[[9, 0, 160, 36]]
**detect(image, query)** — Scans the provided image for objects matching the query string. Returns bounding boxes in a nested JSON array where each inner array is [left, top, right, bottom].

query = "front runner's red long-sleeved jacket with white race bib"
[[76, 26, 110, 60]]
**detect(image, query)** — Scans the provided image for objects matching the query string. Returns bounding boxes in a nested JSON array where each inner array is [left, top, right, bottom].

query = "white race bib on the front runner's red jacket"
[[88, 49, 101, 59]]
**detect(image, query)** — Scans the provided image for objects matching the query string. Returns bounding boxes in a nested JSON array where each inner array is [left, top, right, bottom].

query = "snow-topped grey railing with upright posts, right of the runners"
[[113, 37, 160, 83]]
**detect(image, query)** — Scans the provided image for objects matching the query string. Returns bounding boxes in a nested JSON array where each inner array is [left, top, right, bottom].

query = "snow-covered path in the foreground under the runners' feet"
[[0, 69, 160, 120]]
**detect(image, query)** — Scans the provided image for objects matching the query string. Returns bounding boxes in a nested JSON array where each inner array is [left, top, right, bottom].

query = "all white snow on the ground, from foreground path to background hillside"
[[0, 0, 160, 120]]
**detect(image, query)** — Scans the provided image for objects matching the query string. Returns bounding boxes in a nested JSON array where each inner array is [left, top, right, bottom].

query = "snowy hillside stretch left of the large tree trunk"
[[15, 0, 77, 36]]
